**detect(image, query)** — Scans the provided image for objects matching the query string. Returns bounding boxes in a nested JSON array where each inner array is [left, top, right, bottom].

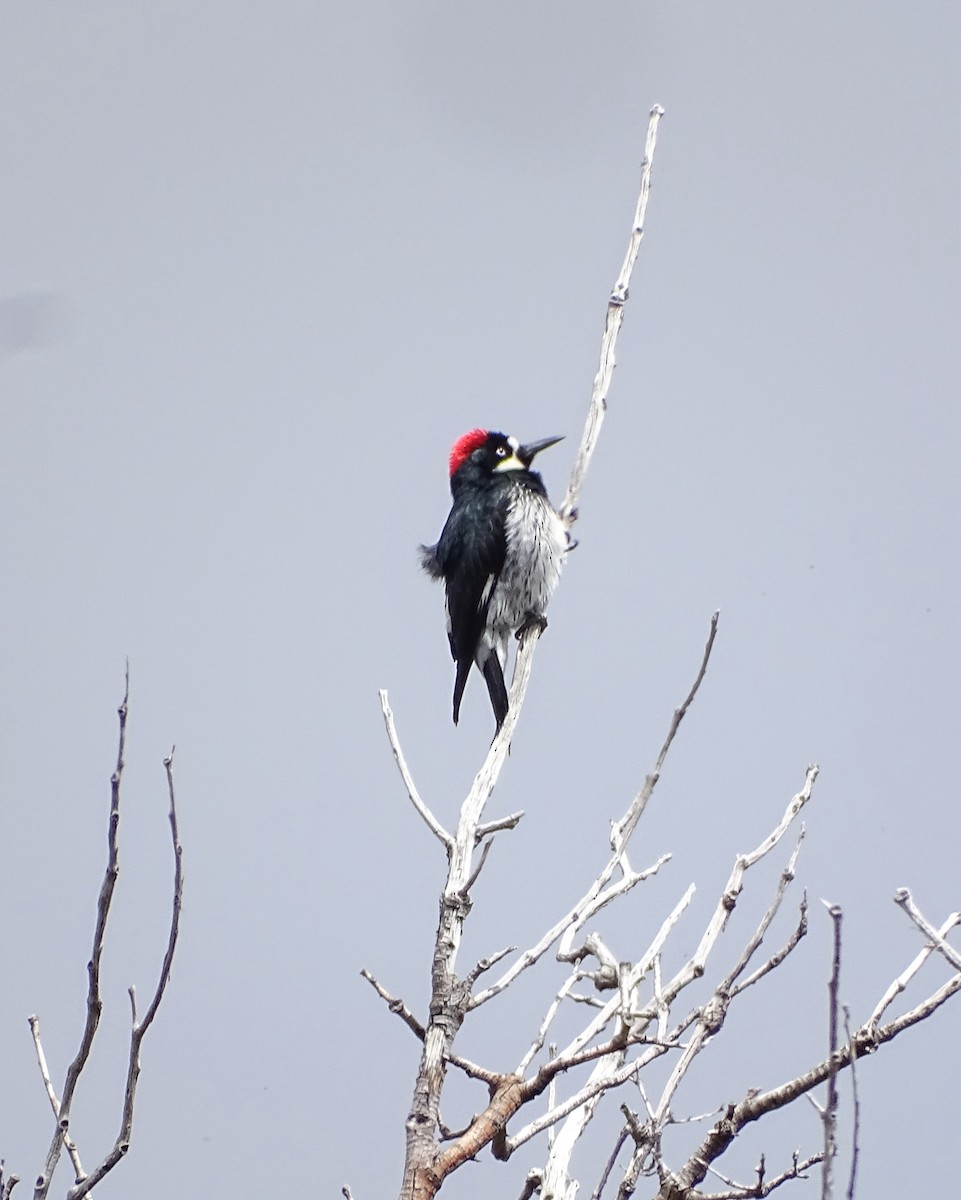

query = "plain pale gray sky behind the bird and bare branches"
[[0, 0, 961, 1200]]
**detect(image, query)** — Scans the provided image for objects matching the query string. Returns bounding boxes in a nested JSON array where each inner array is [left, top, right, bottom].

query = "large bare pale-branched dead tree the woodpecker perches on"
[[355, 107, 961, 1200]]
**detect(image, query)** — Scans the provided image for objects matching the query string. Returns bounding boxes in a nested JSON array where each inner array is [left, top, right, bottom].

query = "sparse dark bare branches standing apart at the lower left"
[[0, 673, 184, 1200]]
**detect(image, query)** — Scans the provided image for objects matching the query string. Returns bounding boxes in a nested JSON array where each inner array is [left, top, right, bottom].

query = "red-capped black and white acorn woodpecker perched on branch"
[[420, 430, 567, 730]]
